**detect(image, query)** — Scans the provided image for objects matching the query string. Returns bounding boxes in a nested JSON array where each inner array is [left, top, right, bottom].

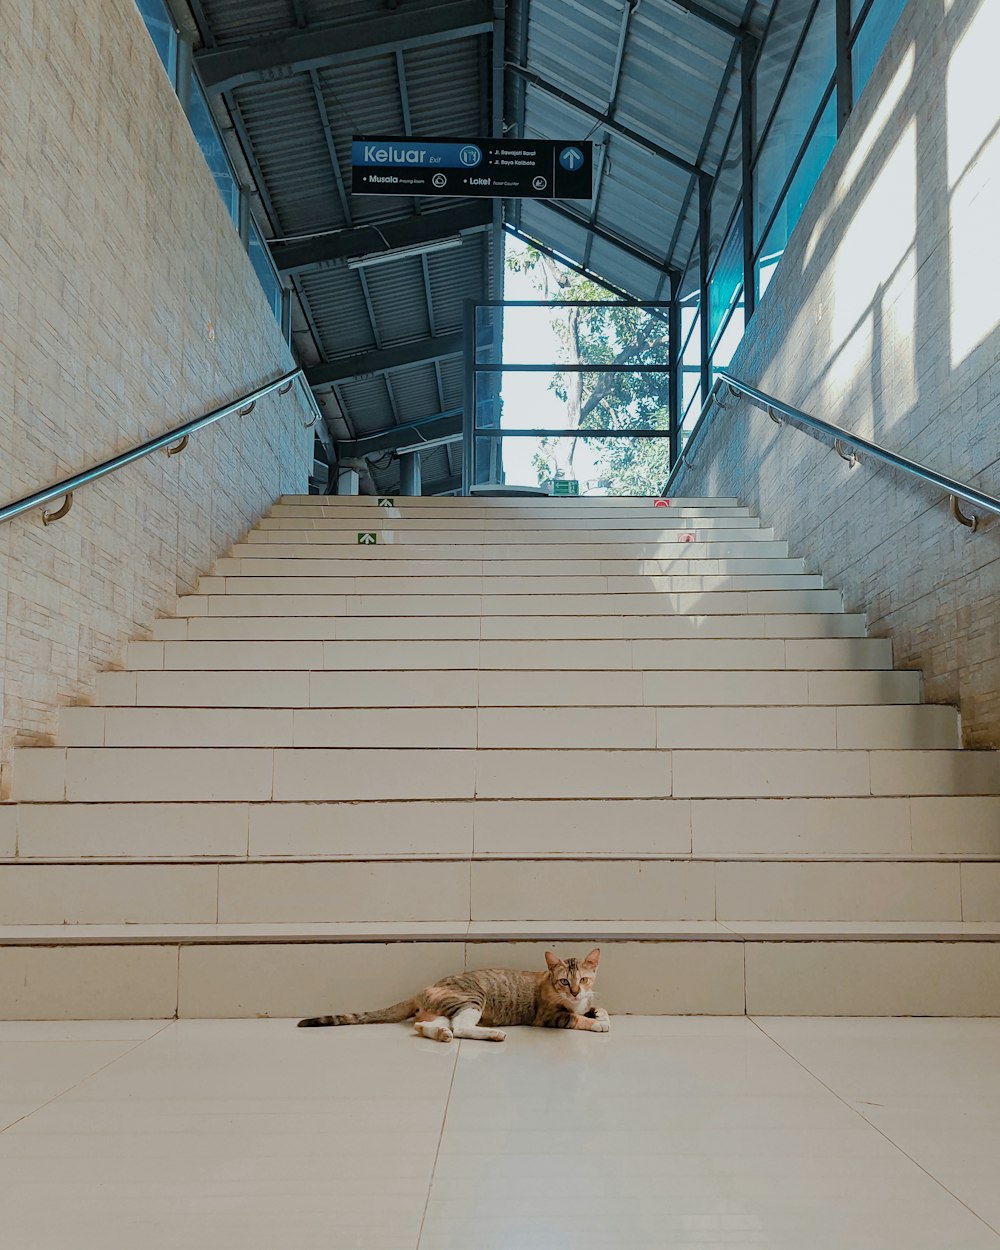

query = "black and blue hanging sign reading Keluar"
[[351, 138, 594, 200]]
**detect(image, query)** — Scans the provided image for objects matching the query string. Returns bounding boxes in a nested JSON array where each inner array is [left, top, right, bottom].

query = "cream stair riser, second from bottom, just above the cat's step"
[[0, 855, 1000, 925]]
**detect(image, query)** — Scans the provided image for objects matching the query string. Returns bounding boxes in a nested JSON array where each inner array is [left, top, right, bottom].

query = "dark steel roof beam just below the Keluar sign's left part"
[[271, 200, 493, 274]]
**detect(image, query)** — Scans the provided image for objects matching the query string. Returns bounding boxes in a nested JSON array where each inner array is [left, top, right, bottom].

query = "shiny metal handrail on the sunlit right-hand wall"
[[660, 373, 1000, 529]]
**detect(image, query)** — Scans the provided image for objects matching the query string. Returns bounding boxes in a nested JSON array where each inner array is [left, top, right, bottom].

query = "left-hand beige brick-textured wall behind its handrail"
[[0, 0, 313, 785]]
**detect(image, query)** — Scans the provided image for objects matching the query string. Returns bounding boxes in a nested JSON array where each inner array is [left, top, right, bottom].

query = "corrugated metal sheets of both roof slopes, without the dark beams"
[[196, 0, 790, 488]]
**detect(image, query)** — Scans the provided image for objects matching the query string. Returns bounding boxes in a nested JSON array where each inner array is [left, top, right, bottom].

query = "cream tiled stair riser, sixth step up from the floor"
[[91, 669, 915, 705]]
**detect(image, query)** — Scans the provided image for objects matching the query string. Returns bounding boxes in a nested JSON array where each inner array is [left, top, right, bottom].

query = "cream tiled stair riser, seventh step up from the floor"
[[128, 638, 893, 673]]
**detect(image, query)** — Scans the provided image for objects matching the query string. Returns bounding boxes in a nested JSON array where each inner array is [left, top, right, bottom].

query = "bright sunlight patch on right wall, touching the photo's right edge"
[[948, 4, 1000, 368]]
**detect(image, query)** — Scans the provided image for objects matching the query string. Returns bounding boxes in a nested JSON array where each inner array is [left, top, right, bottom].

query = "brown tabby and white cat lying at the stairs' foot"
[[299, 948, 608, 1041]]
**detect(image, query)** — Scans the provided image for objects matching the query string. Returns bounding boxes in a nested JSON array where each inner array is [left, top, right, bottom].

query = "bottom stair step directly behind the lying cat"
[[0, 921, 1000, 1028]]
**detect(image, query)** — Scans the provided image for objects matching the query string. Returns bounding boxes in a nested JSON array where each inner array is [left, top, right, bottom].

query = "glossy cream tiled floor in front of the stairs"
[[0, 1020, 1000, 1250]]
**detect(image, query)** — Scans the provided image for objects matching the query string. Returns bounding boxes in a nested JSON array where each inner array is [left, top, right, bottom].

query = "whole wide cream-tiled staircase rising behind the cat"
[[0, 496, 1000, 1018]]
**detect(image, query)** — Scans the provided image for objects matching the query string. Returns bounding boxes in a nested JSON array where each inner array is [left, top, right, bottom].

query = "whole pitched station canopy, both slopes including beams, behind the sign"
[[191, 0, 775, 494]]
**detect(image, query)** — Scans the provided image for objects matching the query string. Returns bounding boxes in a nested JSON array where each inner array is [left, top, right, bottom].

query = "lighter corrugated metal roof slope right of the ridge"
[[508, 0, 775, 298]]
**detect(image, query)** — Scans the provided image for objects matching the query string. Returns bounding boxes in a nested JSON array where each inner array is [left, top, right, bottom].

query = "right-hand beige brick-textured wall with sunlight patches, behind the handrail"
[[673, 0, 1000, 746]]
